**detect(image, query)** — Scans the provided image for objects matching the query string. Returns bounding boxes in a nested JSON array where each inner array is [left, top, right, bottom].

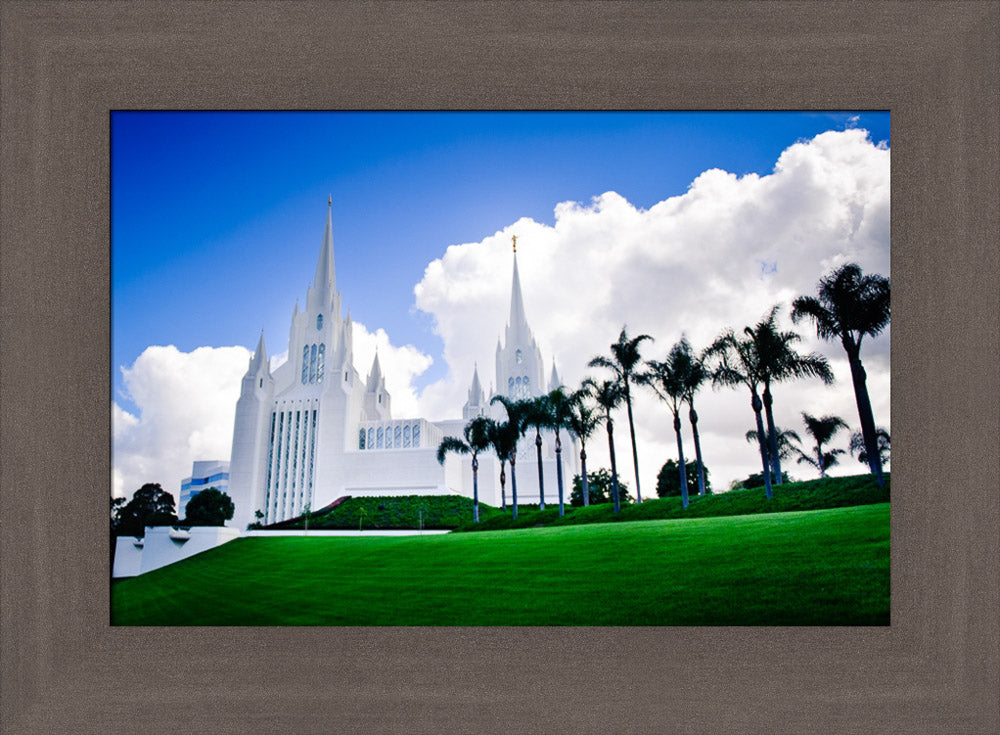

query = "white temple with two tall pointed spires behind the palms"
[[230, 203, 579, 528]]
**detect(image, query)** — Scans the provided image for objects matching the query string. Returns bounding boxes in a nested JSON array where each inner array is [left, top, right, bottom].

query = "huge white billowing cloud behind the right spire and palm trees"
[[414, 129, 889, 493]]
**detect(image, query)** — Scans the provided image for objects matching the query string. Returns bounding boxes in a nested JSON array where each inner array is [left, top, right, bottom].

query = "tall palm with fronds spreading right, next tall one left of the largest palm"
[[744, 306, 833, 485]]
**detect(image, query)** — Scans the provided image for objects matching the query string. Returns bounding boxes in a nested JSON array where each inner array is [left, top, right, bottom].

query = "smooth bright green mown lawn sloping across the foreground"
[[112, 503, 889, 625]]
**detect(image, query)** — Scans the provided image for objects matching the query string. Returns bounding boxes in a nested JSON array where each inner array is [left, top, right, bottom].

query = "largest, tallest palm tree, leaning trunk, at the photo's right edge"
[[792, 263, 890, 487]]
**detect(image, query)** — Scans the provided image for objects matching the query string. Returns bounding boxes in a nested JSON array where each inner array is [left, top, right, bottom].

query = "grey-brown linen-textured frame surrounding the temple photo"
[[0, 1, 1000, 735]]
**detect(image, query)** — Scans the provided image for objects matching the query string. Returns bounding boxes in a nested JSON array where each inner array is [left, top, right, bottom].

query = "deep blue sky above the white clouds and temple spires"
[[111, 112, 889, 407]]
